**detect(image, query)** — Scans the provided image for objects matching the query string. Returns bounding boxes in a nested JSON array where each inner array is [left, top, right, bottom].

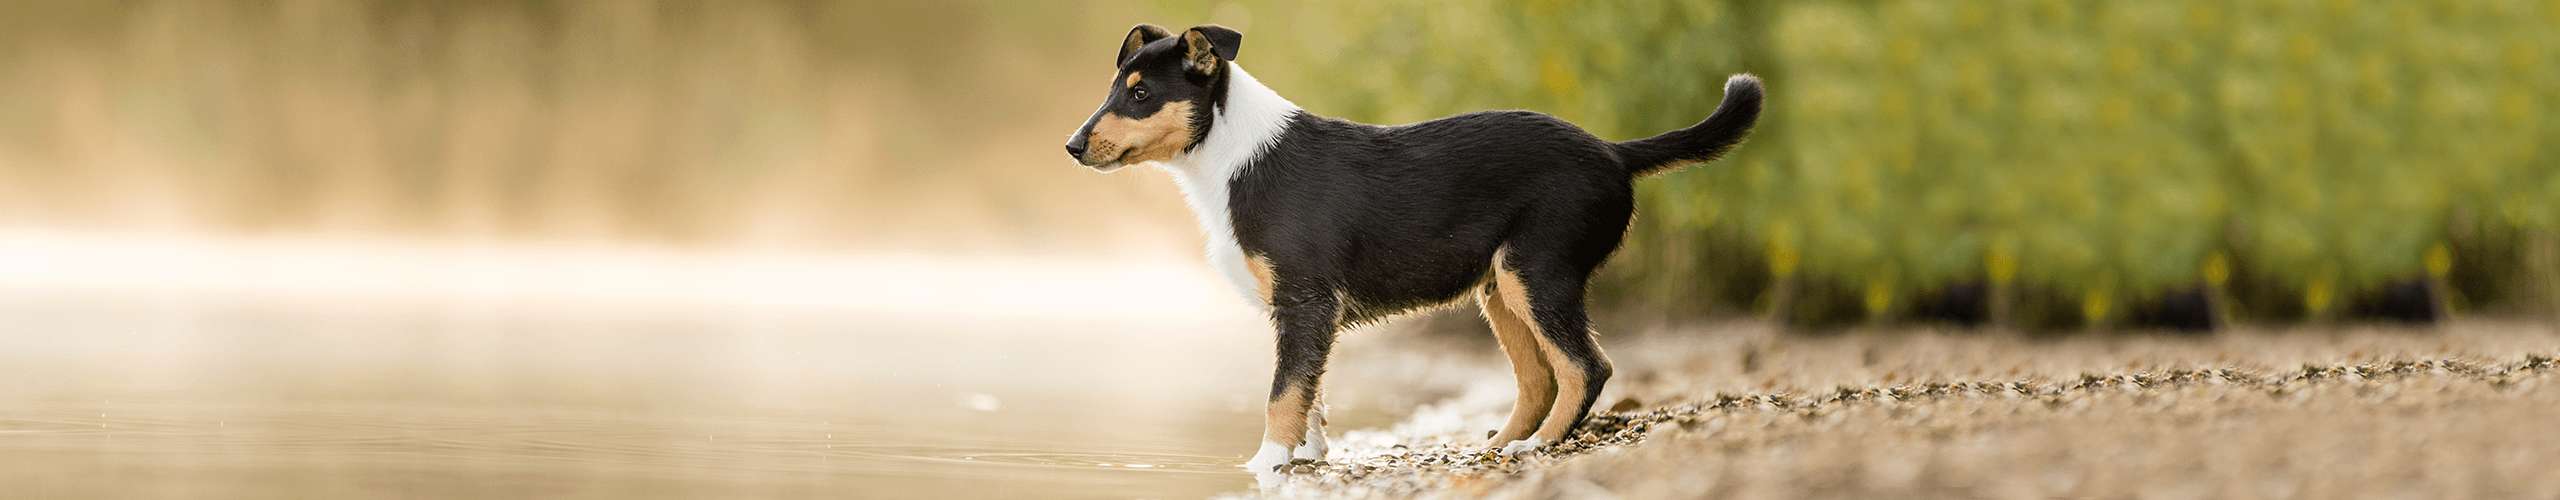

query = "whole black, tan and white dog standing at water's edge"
[[1068, 26, 1761, 474]]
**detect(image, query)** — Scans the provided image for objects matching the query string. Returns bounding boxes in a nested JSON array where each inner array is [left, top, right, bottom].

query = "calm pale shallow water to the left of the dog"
[[0, 235, 1402, 497]]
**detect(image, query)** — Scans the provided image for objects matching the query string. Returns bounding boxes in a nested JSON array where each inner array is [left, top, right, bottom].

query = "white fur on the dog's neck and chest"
[[1157, 62, 1298, 300]]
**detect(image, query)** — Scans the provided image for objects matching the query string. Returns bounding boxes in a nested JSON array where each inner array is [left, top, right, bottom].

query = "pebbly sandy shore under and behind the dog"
[[1260, 321, 2560, 497]]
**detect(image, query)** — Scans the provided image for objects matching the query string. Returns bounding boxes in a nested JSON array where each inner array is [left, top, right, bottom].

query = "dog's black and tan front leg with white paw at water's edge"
[[1244, 292, 1341, 479]]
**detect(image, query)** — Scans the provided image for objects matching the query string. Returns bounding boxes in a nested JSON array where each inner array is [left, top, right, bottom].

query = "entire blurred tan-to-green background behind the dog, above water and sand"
[[0, 0, 2560, 328]]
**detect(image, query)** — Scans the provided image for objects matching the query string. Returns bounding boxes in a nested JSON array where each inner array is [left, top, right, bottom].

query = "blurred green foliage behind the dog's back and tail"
[[1167, 0, 2560, 328]]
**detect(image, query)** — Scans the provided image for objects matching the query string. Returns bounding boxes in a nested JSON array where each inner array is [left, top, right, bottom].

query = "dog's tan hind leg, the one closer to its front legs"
[[1475, 251, 1556, 446]]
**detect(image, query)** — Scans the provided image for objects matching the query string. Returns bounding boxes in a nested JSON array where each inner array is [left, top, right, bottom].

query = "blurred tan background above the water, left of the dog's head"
[[0, 0, 1196, 254]]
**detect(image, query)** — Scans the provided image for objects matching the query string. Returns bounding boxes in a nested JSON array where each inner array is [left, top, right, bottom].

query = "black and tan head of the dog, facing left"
[[1068, 23, 1244, 172]]
